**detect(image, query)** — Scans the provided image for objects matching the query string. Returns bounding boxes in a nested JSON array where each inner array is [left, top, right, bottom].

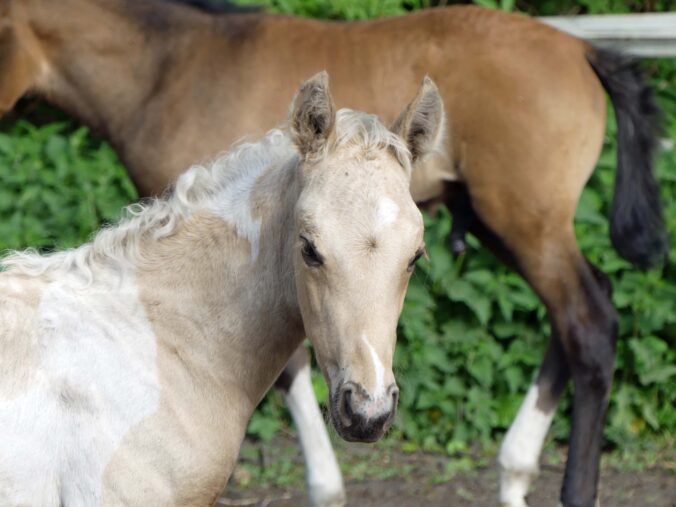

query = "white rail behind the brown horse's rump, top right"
[[539, 12, 676, 58]]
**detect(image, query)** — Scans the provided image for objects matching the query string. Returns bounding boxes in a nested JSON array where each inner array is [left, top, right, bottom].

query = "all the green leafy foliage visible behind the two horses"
[[0, 0, 676, 460]]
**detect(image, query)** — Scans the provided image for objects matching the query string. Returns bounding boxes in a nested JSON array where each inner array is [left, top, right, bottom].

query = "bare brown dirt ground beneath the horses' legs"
[[216, 438, 676, 507]]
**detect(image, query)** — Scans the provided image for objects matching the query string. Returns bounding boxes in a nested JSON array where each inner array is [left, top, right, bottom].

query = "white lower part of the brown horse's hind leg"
[[498, 384, 555, 507]]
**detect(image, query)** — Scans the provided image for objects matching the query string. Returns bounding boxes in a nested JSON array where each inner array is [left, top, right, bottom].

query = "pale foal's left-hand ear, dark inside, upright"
[[289, 71, 336, 158]]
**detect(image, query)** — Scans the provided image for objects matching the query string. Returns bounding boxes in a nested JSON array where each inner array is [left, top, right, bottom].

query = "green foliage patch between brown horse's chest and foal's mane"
[[0, 121, 136, 254]]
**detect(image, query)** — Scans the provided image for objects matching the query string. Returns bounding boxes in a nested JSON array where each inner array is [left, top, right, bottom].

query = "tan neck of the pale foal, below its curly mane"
[[138, 151, 304, 408]]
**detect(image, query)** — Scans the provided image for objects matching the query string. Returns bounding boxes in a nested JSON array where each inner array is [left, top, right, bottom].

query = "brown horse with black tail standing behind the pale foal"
[[0, 0, 665, 507]]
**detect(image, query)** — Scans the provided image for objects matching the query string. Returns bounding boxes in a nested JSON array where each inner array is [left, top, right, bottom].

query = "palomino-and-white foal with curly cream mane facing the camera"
[[0, 73, 444, 506]]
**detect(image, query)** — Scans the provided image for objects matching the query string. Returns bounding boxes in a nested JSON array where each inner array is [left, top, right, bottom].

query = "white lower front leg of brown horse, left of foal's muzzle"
[[276, 346, 345, 507]]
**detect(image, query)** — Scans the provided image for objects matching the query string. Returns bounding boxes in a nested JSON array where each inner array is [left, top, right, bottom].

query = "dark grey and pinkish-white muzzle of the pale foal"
[[331, 382, 399, 442]]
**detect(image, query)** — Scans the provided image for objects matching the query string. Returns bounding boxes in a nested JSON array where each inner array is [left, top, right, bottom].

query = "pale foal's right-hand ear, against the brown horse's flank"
[[392, 76, 446, 164]]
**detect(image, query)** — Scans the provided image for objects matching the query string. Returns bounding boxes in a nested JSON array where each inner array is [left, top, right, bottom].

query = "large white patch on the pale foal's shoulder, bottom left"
[[0, 276, 160, 506]]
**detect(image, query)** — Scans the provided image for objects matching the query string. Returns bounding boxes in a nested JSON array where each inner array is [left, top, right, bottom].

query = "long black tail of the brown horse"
[[588, 49, 667, 269]]
